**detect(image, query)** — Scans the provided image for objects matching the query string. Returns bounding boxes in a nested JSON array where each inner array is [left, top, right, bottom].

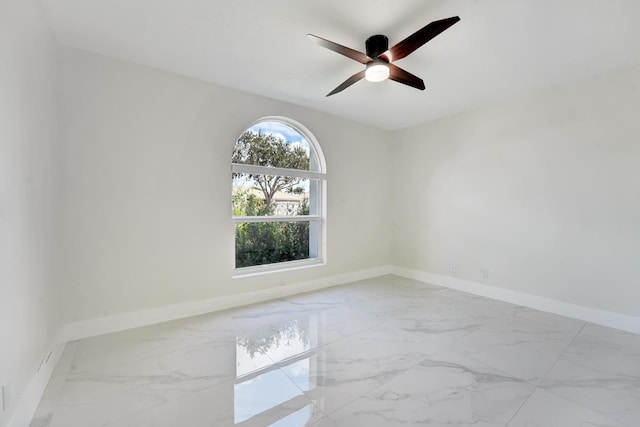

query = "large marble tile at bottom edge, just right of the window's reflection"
[[329, 351, 534, 427]]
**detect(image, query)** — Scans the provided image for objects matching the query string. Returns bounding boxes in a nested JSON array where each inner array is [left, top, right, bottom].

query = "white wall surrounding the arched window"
[[59, 48, 391, 321]]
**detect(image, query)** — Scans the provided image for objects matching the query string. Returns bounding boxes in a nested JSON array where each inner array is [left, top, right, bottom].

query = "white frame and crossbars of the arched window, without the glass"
[[231, 116, 327, 278]]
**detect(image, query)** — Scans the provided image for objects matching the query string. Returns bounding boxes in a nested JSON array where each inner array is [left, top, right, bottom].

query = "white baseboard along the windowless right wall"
[[391, 266, 640, 334]]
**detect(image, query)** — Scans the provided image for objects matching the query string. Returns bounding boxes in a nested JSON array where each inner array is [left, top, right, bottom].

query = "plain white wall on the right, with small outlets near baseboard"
[[392, 64, 640, 316]]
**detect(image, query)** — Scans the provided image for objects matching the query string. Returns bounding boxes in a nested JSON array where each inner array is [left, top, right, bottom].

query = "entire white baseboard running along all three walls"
[[22, 266, 640, 427]]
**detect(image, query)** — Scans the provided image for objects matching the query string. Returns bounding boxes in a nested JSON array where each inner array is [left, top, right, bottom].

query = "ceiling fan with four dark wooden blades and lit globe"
[[307, 16, 460, 96]]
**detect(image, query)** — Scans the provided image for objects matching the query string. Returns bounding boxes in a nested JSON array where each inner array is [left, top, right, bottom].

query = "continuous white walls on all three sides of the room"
[[0, 9, 640, 425]]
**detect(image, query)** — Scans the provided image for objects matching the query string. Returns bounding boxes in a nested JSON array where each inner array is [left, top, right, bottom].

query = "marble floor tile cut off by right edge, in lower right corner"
[[540, 325, 640, 426]]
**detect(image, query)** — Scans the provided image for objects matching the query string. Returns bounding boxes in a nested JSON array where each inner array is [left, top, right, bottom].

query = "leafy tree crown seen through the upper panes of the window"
[[232, 130, 309, 206]]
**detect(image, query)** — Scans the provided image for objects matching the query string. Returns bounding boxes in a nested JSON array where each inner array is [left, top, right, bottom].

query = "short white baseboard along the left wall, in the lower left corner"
[[9, 343, 65, 427]]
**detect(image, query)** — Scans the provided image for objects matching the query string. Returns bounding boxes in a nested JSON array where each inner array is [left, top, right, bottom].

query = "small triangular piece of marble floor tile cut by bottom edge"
[[508, 389, 619, 427]]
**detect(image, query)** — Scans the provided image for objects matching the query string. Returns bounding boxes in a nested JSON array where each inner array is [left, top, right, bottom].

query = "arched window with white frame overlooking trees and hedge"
[[231, 117, 326, 273]]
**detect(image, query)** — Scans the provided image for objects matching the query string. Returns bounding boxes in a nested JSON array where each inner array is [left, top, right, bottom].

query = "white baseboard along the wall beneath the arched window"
[[56, 266, 391, 342]]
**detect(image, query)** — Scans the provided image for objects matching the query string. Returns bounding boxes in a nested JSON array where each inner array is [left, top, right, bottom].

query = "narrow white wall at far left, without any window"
[[0, 0, 57, 425]]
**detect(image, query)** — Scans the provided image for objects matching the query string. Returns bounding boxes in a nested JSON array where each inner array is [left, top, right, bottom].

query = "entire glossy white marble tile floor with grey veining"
[[31, 275, 640, 427]]
